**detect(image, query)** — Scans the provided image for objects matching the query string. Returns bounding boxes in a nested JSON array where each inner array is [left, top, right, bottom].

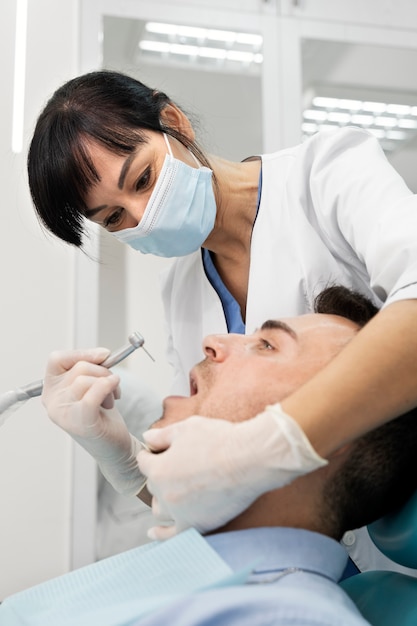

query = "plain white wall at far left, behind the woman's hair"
[[0, 0, 78, 600]]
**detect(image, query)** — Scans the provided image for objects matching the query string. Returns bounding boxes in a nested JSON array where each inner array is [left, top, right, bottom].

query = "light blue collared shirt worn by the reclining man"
[[138, 528, 369, 626]]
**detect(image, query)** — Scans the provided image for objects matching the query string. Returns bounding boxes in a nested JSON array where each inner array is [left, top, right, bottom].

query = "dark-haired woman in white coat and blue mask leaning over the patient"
[[28, 71, 417, 568]]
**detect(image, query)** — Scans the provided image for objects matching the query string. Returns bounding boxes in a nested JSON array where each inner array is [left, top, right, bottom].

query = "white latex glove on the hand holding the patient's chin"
[[138, 404, 327, 539]]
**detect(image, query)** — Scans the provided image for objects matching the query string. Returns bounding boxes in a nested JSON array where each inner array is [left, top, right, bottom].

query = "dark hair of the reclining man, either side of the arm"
[[315, 286, 417, 539]]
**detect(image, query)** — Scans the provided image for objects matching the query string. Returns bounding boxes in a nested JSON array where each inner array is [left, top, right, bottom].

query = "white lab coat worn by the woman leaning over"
[[162, 128, 417, 572]]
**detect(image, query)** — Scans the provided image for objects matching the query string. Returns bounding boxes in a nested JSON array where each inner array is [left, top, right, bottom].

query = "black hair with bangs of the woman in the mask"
[[28, 70, 209, 247]]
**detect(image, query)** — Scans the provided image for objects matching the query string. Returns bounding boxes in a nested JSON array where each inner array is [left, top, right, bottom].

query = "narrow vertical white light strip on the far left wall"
[[12, 0, 27, 154]]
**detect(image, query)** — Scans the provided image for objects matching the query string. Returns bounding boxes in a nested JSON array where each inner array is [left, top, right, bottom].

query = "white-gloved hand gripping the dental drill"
[[42, 348, 146, 495]]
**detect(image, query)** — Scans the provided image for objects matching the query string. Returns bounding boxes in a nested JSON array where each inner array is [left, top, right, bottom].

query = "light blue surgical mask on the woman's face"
[[112, 134, 216, 257]]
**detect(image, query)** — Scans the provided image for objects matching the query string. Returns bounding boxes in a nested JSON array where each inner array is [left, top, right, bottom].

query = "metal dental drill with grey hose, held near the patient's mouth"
[[0, 331, 155, 426]]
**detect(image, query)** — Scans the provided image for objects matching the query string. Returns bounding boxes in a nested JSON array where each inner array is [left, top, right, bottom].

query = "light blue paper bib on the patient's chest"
[[0, 529, 251, 626]]
